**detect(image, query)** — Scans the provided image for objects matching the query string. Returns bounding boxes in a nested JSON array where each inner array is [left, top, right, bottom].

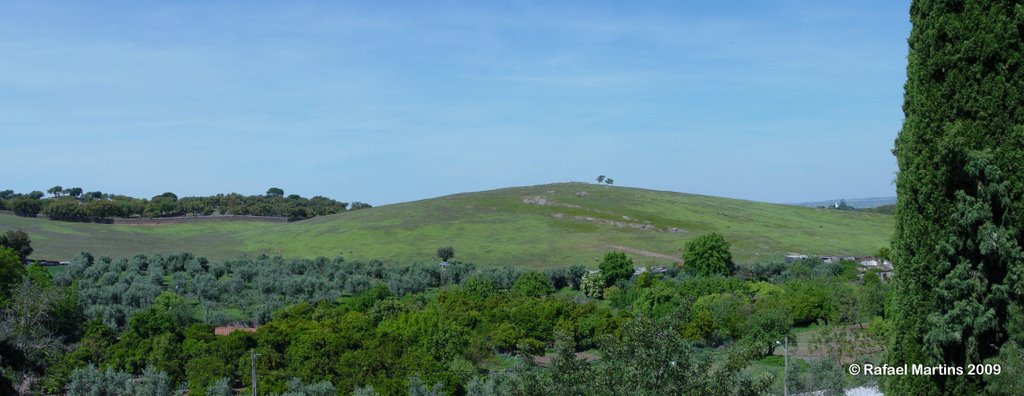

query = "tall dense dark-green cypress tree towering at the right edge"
[[884, 0, 1024, 394]]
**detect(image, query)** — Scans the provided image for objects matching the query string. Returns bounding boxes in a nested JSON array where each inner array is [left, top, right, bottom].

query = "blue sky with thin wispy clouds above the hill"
[[0, 0, 910, 205]]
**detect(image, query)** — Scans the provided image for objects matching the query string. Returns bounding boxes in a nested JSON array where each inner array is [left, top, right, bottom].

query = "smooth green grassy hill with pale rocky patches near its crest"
[[0, 183, 893, 268]]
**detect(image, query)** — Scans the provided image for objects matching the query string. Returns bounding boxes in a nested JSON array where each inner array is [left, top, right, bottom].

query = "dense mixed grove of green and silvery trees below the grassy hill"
[[0, 240, 888, 395]]
